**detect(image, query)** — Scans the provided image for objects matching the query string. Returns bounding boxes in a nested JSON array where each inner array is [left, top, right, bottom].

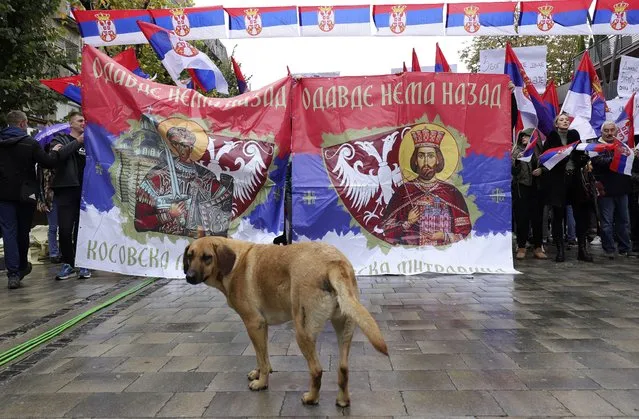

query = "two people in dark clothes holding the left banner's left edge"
[[0, 111, 91, 289]]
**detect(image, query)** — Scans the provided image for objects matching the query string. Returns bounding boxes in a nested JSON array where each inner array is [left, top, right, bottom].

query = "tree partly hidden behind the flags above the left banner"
[[74, 0, 239, 97]]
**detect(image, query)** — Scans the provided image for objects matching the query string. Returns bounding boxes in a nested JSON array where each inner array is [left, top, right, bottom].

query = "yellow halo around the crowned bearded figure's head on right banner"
[[399, 124, 459, 181]]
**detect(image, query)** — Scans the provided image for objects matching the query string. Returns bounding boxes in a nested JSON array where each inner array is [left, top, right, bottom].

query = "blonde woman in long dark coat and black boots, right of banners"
[[542, 114, 593, 262]]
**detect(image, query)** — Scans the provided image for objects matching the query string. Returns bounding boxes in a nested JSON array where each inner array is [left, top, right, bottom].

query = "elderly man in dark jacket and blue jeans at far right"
[[592, 121, 639, 259]]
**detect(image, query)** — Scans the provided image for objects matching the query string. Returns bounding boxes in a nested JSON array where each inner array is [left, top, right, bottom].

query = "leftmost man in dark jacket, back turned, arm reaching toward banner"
[[0, 111, 82, 289]]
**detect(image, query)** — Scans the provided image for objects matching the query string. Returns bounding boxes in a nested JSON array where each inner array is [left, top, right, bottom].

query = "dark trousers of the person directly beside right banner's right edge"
[[513, 184, 544, 248]]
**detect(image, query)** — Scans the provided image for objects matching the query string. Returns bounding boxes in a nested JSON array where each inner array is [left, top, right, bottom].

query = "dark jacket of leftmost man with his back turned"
[[0, 127, 79, 203]]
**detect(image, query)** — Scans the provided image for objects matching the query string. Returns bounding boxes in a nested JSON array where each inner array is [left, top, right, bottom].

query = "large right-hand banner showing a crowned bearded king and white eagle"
[[292, 73, 515, 275]]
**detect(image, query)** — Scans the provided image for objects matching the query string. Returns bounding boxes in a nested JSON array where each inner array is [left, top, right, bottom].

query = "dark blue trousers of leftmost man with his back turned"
[[0, 201, 35, 277]]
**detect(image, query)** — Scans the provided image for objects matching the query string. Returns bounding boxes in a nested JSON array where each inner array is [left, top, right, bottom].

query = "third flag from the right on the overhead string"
[[446, 2, 517, 35]]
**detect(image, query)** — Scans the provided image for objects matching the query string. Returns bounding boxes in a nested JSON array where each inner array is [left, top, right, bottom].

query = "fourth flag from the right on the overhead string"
[[373, 3, 444, 36]]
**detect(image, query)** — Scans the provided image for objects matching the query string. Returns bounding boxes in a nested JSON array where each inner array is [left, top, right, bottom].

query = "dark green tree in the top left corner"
[[0, 0, 74, 124]]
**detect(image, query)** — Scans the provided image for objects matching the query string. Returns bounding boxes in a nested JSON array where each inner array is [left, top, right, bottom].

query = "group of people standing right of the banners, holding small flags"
[[512, 114, 639, 262]]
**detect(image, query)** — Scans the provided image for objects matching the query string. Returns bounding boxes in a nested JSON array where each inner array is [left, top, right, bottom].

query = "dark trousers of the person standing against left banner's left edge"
[[55, 188, 81, 267]]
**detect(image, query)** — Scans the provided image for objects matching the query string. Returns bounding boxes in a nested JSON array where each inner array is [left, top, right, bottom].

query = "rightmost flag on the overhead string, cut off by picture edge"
[[591, 0, 639, 35]]
